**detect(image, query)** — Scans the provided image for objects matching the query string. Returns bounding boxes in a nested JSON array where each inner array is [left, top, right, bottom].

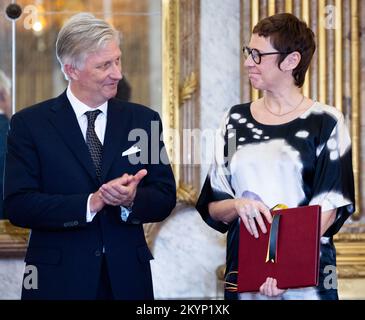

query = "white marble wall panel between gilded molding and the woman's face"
[[200, 0, 241, 182]]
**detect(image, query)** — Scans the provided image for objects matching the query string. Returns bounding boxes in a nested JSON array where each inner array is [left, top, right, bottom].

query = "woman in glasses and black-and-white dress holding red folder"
[[196, 13, 354, 299]]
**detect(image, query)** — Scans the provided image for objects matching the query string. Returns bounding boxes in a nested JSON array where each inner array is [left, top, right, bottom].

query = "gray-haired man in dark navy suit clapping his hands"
[[4, 14, 176, 299]]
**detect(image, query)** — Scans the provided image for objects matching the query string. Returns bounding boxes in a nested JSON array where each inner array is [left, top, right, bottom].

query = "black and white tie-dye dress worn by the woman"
[[196, 102, 355, 299]]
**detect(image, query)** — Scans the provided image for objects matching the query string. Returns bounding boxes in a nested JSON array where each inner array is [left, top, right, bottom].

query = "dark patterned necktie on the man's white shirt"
[[85, 110, 103, 177]]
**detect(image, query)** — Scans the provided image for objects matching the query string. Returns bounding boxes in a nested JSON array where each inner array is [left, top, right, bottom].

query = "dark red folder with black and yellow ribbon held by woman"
[[237, 206, 321, 292]]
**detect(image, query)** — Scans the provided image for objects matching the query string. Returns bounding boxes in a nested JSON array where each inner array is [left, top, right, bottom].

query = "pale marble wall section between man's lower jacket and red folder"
[[151, 207, 225, 299]]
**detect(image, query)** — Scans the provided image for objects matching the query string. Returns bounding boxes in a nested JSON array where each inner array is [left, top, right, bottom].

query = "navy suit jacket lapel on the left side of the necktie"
[[49, 92, 98, 184]]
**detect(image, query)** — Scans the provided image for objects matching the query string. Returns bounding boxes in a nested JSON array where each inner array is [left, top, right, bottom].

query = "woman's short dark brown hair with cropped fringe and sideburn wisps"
[[252, 13, 316, 88]]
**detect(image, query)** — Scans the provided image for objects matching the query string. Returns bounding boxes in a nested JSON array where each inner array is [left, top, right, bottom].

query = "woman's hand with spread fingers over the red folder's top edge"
[[235, 198, 272, 238]]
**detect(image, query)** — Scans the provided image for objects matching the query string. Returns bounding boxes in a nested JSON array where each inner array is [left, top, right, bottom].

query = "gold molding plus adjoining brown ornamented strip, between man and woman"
[[162, 0, 200, 203]]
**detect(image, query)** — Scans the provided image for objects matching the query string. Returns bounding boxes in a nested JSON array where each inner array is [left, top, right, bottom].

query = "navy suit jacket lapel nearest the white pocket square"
[[101, 99, 131, 181]]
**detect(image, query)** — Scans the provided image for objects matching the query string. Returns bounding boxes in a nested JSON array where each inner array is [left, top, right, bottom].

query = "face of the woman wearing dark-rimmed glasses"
[[244, 34, 284, 90]]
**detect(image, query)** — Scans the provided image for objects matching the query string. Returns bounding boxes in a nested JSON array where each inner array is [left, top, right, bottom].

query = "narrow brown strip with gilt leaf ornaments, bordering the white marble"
[[177, 0, 200, 205]]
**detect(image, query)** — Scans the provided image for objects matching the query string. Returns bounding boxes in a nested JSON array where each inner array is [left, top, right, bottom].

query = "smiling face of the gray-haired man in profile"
[[70, 40, 122, 107]]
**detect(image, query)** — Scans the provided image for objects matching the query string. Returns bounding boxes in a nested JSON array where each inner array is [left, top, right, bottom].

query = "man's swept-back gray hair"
[[56, 13, 120, 79]]
